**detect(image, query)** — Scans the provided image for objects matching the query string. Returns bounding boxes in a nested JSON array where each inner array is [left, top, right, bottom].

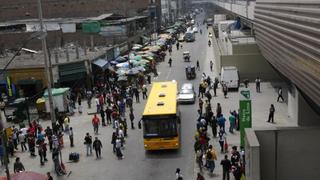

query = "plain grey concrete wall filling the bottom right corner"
[[248, 127, 320, 180]]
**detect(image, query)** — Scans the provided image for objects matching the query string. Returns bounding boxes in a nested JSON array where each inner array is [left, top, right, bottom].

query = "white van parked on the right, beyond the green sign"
[[220, 66, 240, 90]]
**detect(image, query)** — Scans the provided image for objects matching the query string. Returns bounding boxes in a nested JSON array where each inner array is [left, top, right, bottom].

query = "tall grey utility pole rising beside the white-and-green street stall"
[[38, 0, 56, 129]]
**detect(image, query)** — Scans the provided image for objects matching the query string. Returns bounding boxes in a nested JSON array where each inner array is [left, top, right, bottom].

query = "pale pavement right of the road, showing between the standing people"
[[194, 29, 296, 180]]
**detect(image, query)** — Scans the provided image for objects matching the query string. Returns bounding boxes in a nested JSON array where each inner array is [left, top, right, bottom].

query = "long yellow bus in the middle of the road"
[[142, 81, 180, 150]]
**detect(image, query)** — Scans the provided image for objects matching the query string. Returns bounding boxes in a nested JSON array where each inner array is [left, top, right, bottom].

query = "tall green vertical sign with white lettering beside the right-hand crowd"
[[239, 90, 252, 147]]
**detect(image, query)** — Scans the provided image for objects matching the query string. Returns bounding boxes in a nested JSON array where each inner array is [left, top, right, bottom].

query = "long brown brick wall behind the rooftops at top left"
[[0, 0, 149, 21]]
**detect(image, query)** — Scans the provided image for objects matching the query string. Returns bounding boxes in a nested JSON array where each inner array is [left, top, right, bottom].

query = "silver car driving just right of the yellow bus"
[[178, 83, 196, 103]]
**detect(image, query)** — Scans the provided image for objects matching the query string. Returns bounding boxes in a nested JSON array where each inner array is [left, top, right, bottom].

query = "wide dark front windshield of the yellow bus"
[[143, 117, 178, 137]]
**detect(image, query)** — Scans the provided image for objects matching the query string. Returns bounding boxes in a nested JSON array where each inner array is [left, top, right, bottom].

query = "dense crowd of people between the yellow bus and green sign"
[[194, 73, 245, 180]]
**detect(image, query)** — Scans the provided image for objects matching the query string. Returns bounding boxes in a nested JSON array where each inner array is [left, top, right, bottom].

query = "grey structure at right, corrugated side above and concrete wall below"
[[194, 0, 320, 180]]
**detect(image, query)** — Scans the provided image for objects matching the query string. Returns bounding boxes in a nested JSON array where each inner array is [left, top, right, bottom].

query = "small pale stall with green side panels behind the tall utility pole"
[[43, 88, 70, 113]]
